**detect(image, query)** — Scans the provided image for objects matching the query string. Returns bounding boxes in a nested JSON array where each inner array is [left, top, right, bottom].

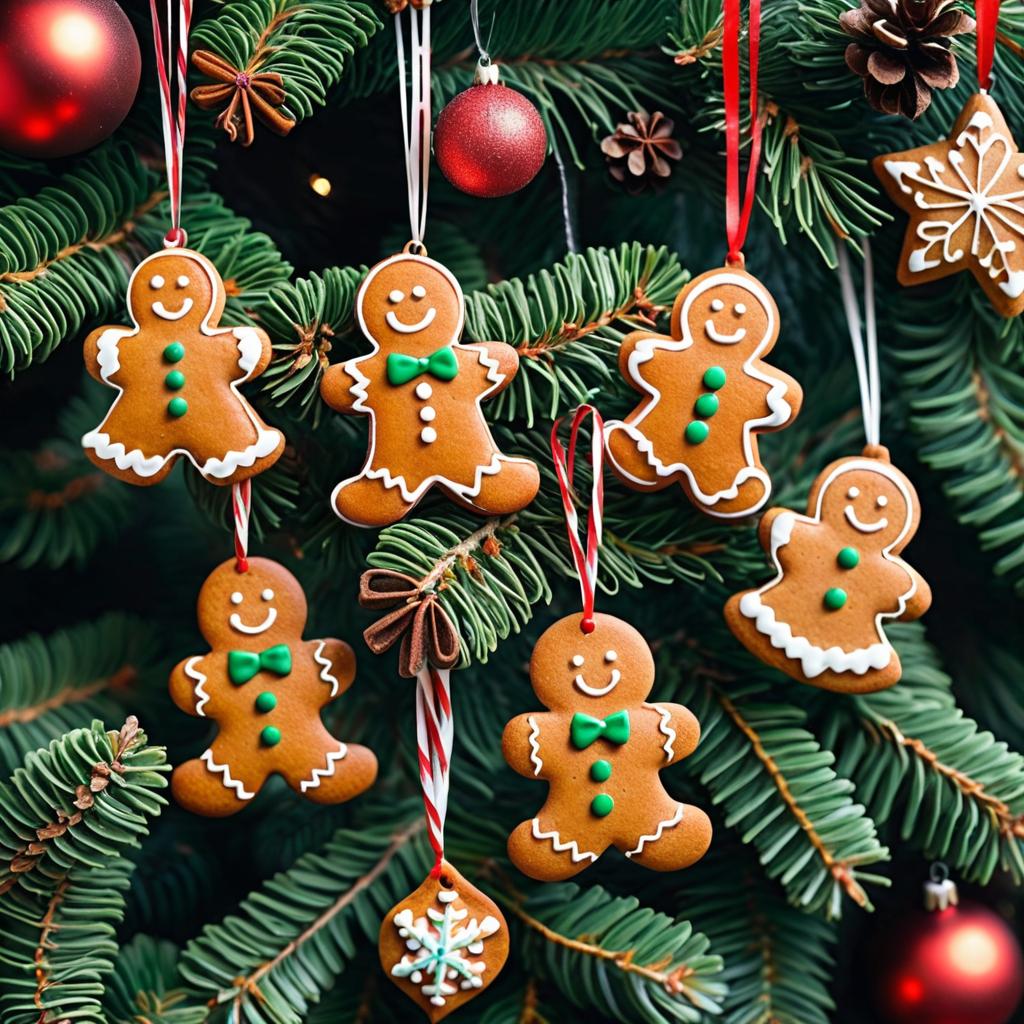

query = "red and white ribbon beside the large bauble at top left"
[[150, 0, 193, 248]]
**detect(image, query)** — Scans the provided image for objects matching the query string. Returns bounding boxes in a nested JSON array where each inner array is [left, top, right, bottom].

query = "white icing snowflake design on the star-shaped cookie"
[[885, 97, 1024, 299]]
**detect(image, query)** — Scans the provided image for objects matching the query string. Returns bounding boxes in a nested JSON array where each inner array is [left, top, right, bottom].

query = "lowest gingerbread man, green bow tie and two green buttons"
[[502, 614, 711, 882]]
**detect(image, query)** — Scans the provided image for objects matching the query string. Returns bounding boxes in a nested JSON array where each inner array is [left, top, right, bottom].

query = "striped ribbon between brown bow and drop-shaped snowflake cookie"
[[416, 665, 455, 879]]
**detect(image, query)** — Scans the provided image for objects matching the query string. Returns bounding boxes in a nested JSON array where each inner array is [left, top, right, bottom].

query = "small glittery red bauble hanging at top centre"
[[434, 84, 548, 199]]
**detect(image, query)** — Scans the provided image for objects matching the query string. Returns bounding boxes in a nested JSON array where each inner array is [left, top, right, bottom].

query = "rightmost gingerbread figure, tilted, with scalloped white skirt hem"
[[725, 447, 932, 693]]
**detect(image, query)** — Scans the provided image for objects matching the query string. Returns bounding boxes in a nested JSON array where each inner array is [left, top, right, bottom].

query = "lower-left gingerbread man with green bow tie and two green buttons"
[[170, 558, 377, 817]]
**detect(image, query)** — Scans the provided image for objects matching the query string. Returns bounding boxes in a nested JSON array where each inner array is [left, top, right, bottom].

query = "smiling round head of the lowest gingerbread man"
[[529, 613, 654, 713]]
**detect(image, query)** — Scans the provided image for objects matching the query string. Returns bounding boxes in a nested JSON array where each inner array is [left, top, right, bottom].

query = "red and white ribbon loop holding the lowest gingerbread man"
[[551, 404, 604, 633]]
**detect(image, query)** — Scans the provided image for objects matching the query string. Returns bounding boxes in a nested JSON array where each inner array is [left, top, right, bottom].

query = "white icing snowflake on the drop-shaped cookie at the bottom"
[[391, 889, 501, 1007]]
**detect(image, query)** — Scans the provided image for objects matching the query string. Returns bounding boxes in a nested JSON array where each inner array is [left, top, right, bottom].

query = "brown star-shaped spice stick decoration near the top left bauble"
[[189, 50, 295, 145]]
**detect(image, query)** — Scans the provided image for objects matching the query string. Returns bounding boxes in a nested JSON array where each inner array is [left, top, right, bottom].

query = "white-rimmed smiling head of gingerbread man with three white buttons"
[[356, 253, 464, 353]]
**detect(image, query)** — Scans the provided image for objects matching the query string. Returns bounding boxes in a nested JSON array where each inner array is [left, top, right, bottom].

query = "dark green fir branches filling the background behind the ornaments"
[[0, 0, 1024, 1024]]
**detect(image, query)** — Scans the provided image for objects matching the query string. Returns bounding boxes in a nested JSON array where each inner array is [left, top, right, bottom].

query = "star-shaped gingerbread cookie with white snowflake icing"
[[872, 92, 1024, 317]]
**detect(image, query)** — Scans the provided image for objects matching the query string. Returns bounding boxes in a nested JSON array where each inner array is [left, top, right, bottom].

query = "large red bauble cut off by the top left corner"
[[0, 0, 142, 158]]
